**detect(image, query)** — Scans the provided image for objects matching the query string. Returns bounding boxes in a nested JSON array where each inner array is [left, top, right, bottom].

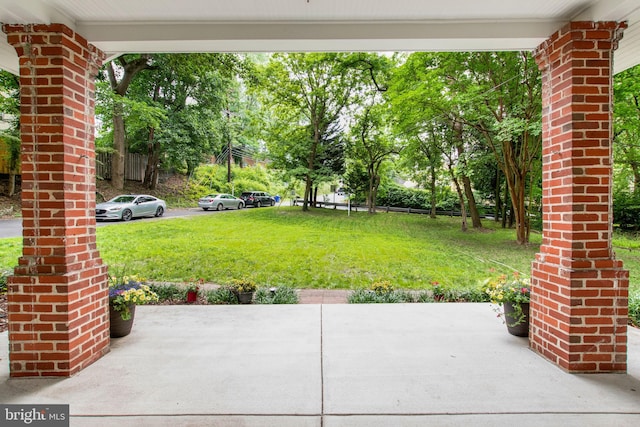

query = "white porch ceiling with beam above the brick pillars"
[[0, 0, 640, 73]]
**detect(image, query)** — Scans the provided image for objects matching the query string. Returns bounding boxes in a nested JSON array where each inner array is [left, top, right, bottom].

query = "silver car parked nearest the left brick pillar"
[[96, 194, 167, 221]]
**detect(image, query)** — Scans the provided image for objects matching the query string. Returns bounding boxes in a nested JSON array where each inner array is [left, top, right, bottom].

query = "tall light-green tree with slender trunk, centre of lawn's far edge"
[[261, 53, 359, 210]]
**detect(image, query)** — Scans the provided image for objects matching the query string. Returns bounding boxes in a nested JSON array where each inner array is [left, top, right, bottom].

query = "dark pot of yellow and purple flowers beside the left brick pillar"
[[109, 276, 158, 338]]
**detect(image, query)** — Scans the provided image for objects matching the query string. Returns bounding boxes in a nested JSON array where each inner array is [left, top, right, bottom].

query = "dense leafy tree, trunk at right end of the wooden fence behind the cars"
[[131, 54, 235, 188]]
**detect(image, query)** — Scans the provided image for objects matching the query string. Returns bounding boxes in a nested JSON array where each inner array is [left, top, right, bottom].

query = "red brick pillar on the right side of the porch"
[[529, 22, 629, 373]]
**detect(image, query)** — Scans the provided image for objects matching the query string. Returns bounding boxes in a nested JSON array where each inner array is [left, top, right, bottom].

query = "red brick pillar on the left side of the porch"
[[2, 24, 109, 377]]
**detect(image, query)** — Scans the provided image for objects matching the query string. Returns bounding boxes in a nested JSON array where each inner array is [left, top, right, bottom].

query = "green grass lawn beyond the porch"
[[0, 207, 640, 289]]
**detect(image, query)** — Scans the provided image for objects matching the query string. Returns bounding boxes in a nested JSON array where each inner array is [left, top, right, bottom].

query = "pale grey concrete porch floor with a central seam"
[[0, 303, 640, 427]]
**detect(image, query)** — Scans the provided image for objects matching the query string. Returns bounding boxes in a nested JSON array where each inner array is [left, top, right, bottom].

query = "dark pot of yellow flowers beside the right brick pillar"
[[483, 272, 531, 337]]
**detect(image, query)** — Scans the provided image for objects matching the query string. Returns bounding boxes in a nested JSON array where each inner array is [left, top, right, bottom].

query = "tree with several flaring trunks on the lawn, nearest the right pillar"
[[439, 52, 542, 244]]
